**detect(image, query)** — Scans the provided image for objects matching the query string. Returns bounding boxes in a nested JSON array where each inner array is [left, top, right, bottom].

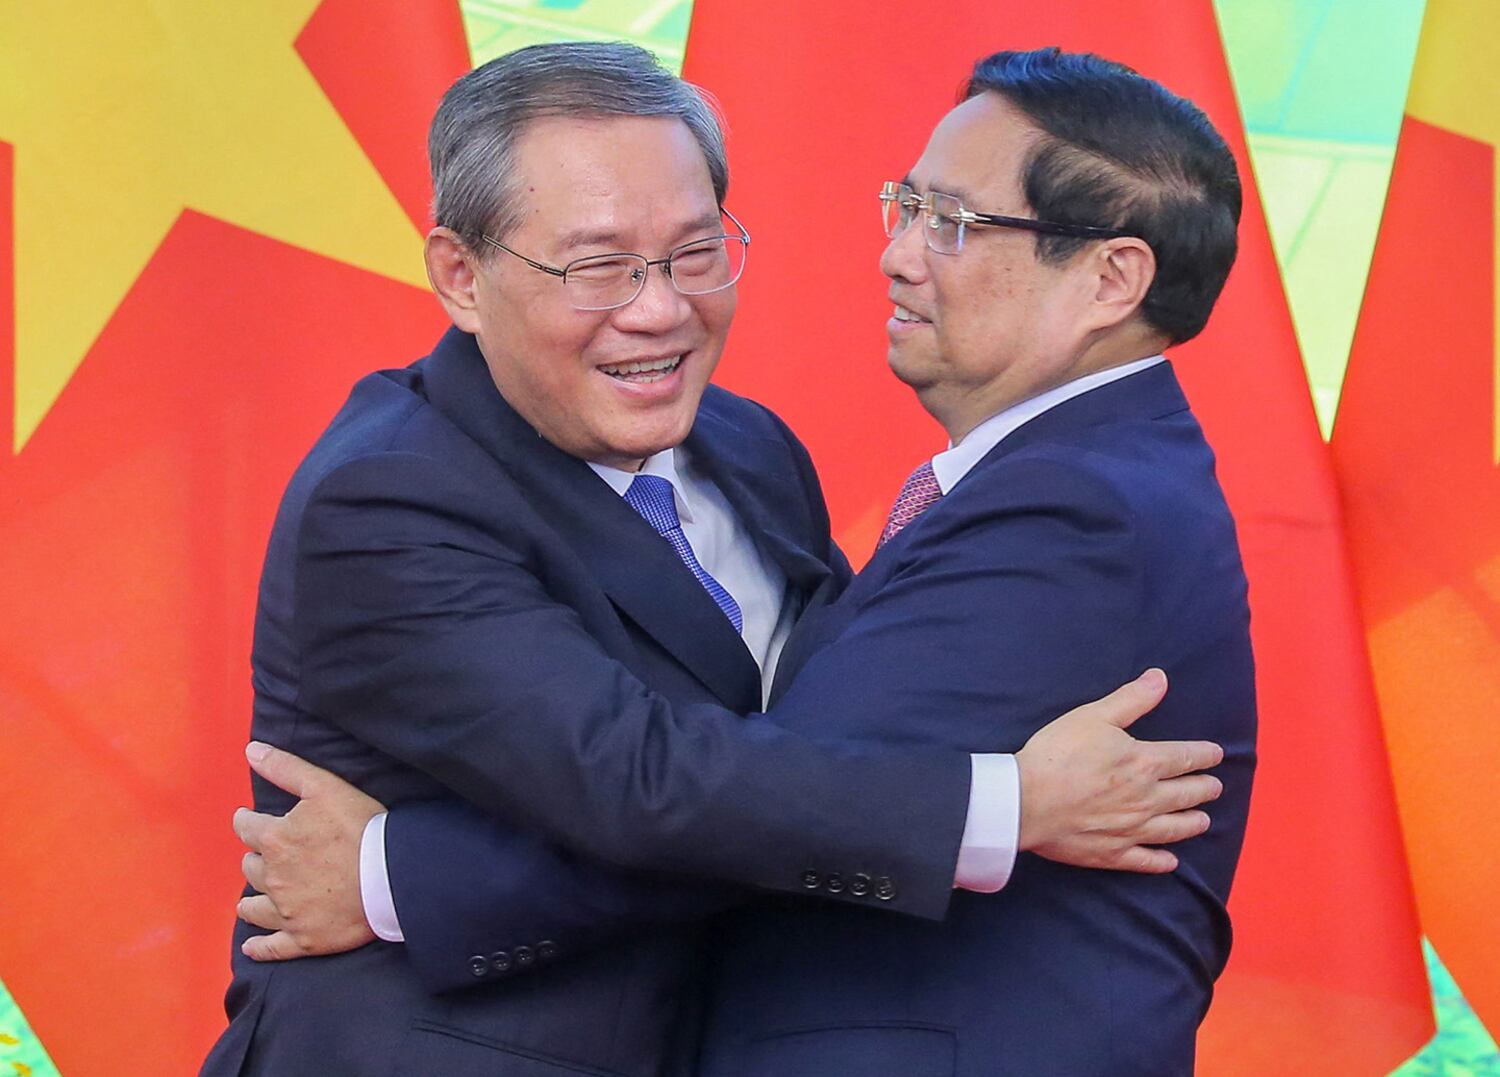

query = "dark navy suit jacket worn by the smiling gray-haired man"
[[204, 330, 968, 1077]]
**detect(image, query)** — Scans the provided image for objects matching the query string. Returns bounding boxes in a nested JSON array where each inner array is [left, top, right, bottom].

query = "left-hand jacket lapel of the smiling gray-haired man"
[[423, 329, 761, 711]]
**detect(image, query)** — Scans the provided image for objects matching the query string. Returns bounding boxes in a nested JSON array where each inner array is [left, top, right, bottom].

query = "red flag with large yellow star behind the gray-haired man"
[[0, 0, 468, 1074]]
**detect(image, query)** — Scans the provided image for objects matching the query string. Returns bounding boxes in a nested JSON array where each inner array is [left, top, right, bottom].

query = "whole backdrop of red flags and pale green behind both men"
[[0, 0, 1500, 1077]]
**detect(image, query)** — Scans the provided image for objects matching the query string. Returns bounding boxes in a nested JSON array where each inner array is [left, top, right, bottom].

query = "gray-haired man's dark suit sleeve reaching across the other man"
[[296, 453, 969, 918]]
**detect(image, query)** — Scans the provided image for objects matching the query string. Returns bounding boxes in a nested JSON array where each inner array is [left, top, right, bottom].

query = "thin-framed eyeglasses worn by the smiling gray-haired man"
[[480, 207, 750, 311]]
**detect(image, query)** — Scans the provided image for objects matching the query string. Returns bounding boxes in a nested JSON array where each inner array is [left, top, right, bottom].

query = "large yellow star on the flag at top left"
[[0, 0, 426, 452]]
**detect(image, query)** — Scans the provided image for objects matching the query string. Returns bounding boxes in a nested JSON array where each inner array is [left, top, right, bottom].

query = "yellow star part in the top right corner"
[[1407, 0, 1500, 464]]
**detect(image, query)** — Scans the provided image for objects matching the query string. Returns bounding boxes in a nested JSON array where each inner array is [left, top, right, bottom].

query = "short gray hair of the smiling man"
[[428, 42, 729, 251]]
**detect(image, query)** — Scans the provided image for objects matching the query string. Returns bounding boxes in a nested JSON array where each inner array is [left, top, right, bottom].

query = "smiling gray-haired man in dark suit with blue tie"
[[207, 47, 1218, 1074]]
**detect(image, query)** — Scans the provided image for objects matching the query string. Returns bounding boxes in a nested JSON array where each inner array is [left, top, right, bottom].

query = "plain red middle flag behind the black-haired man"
[[686, 0, 1433, 1074]]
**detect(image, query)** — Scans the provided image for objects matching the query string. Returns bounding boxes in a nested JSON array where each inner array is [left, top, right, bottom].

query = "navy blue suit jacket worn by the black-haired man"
[[375, 365, 1256, 1077]]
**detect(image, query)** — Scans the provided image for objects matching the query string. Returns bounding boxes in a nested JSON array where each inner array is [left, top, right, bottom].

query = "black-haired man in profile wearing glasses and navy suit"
[[701, 50, 1256, 1077]]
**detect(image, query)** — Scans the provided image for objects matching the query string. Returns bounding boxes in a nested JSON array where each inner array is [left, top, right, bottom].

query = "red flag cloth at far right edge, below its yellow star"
[[1334, 117, 1500, 1029]]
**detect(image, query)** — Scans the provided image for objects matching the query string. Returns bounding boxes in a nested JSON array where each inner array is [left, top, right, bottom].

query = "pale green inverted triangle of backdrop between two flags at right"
[[1215, 0, 1424, 437]]
